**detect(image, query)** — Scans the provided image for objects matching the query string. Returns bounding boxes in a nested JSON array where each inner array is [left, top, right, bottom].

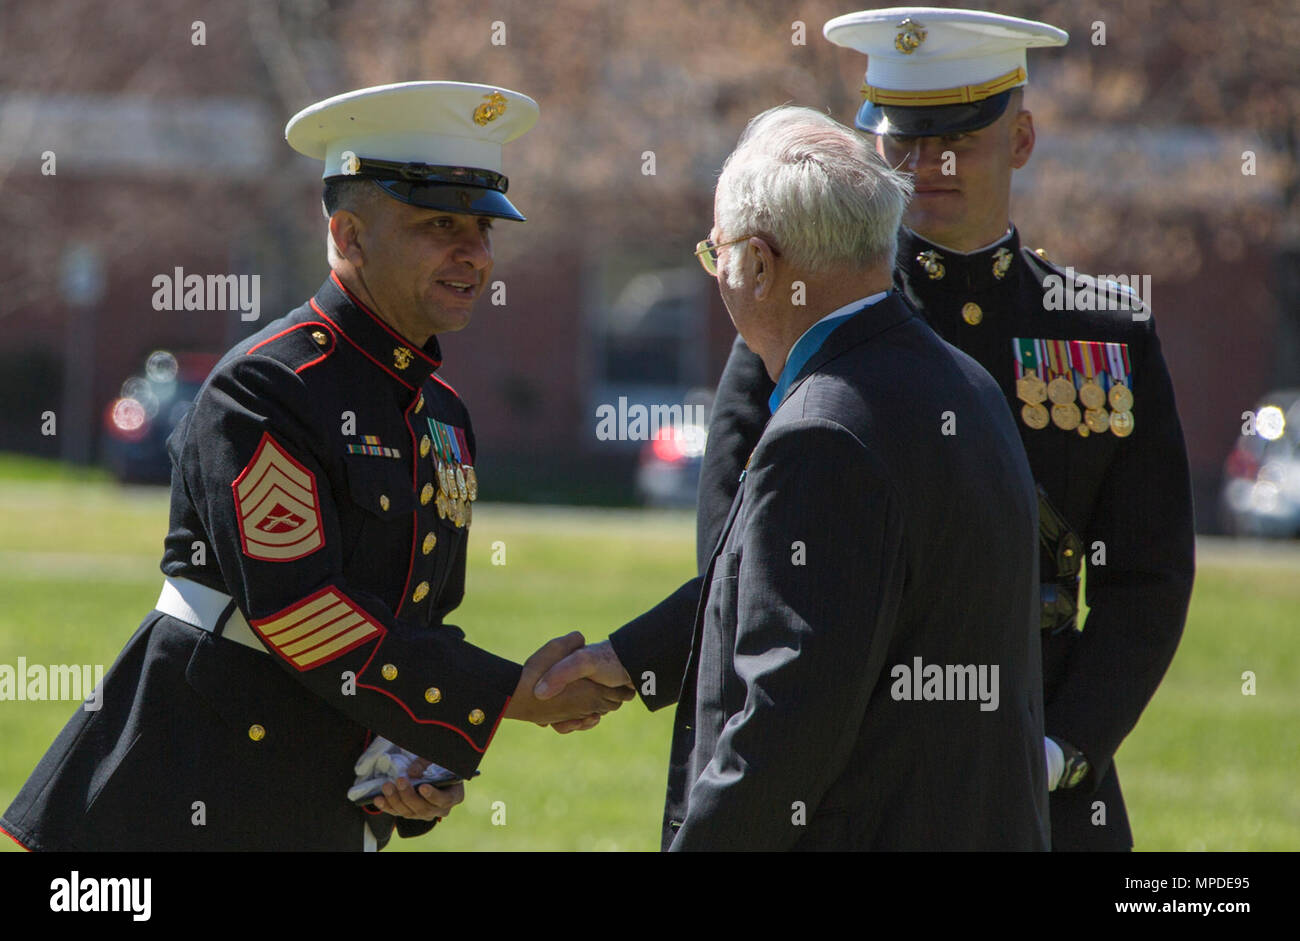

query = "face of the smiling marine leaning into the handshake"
[[361, 198, 493, 343]]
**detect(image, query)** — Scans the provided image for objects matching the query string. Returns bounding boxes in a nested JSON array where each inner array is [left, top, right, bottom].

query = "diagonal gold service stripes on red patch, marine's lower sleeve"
[[251, 586, 384, 671]]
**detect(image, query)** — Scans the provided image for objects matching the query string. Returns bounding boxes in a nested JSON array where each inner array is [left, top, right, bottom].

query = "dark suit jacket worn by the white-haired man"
[[623, 295, 1048, 850]]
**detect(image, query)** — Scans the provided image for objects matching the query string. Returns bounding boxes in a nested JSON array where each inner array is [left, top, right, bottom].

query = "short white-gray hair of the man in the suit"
[[716, 105, 913, 279]]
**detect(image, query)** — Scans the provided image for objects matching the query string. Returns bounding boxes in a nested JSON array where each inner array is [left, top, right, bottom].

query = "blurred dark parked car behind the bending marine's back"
[[103, 350, 220, 483]]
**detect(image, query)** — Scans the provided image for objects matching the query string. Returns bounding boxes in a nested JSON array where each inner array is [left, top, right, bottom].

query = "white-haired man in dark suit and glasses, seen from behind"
[[540, 108, 1048, 850]]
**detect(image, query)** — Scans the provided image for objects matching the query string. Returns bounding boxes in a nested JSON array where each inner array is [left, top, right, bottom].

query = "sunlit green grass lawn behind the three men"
[[0, 473, 1300, 850]]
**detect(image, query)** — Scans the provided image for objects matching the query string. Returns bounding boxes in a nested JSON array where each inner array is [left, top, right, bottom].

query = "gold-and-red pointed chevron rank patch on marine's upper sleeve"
[[230, 433, 325, 561]]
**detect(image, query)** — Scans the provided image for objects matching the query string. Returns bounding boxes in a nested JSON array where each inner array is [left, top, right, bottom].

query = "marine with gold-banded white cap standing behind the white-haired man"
[[543, 8, 1195, 850]]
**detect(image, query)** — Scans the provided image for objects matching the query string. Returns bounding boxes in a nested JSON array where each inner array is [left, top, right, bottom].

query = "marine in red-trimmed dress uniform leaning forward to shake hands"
[[0, 82, 632, 850]]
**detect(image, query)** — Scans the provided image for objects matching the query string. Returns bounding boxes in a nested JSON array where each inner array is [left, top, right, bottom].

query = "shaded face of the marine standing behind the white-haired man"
[[876, 107, 1034, 251]]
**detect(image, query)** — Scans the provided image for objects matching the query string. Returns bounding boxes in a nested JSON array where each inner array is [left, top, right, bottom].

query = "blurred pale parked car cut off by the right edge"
[[1219, 389, 1300, 538]]
